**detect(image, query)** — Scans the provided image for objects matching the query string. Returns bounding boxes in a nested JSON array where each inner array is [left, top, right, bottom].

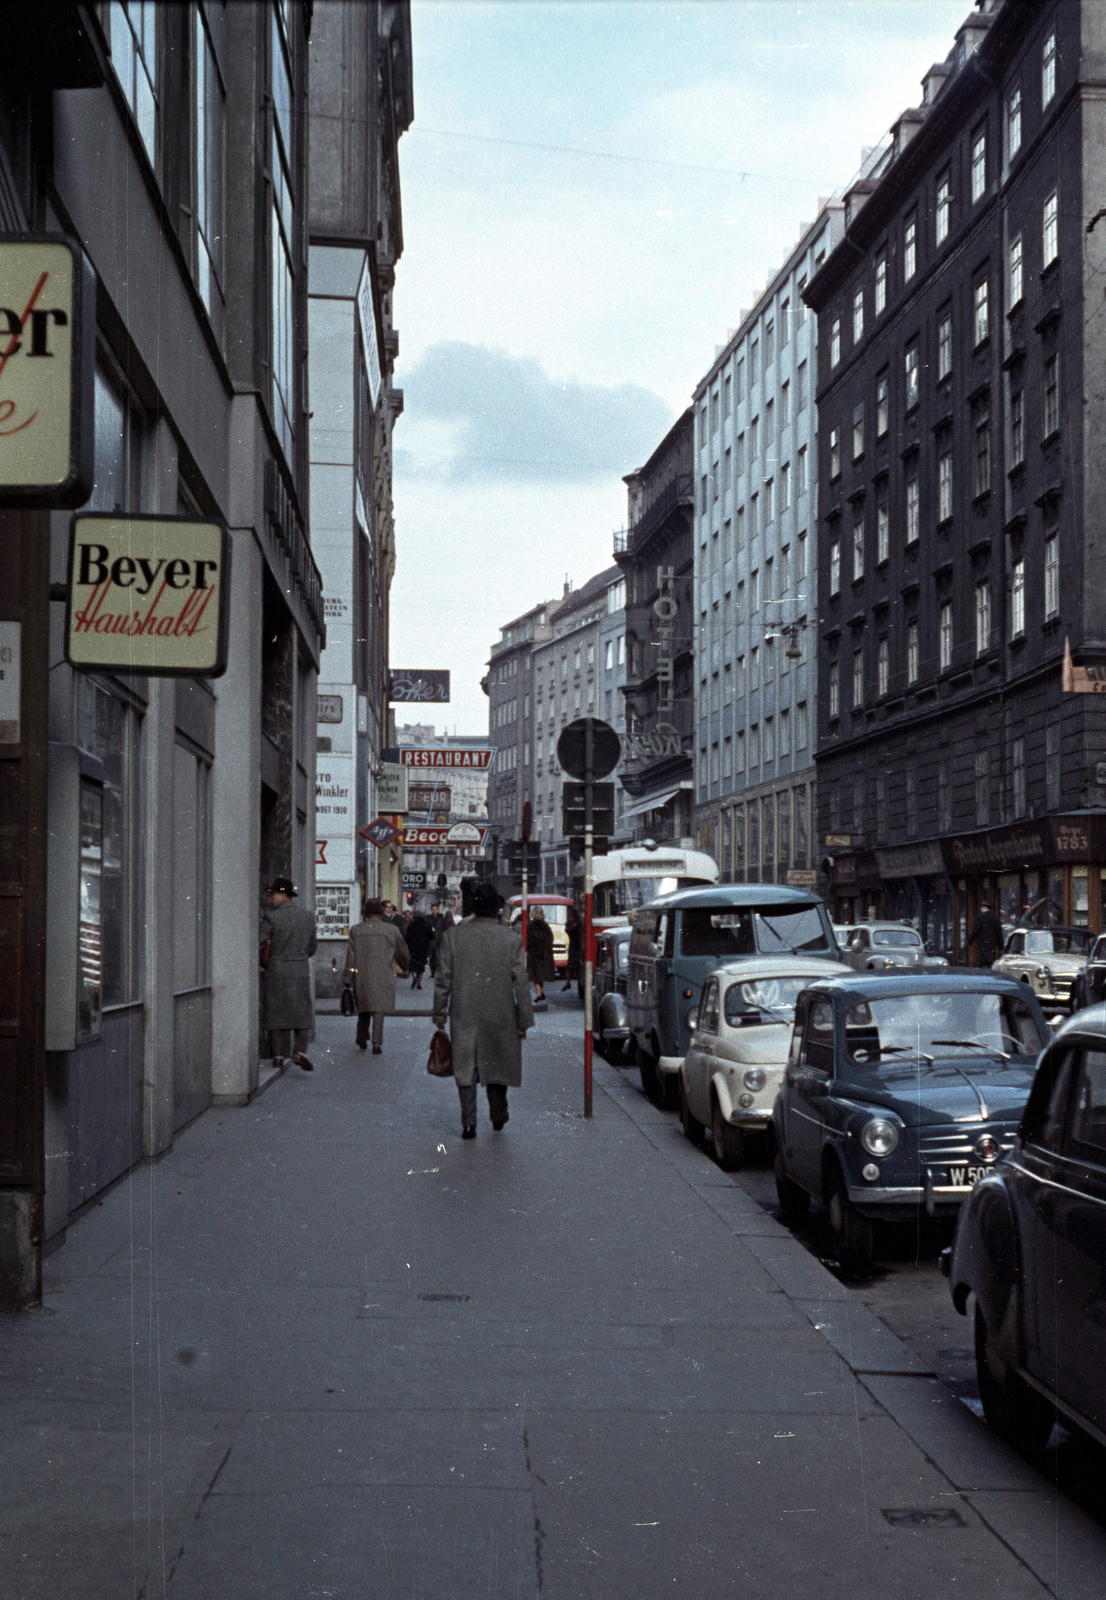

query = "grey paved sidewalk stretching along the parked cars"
[[0, 1011, 1106, 1600]]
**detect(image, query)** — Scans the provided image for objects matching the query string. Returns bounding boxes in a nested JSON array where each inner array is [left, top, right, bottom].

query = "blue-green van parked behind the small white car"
[[626, 883, 839, 1106]]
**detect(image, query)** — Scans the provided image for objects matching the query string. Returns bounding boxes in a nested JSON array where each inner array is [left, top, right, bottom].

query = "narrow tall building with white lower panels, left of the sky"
[[307, 0, 413, 997]]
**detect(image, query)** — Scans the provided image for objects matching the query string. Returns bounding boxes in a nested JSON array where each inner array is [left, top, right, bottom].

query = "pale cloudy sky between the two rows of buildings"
[[391, 0, 970, 734]]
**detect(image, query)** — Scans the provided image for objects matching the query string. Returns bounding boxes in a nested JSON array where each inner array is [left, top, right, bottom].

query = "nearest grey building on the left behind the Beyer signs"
[[0, 0, 323, 1306]]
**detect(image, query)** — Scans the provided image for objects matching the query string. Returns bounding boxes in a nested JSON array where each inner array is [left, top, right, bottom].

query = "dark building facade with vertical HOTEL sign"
[[615, 408, 695, 843]]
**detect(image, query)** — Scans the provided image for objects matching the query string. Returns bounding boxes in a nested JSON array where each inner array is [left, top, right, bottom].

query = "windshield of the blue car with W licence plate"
[[845, 990, 1048, 1078]]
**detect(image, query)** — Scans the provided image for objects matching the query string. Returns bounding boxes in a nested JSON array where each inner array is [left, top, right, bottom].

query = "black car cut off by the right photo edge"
[[941, 1005, 1106, 1448]]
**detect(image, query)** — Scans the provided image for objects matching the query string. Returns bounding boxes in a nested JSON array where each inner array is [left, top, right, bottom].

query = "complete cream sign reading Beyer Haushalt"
[[66, 512, 230, 678]]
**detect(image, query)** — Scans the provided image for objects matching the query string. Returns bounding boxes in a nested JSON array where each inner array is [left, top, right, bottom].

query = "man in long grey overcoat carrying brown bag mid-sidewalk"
[[434, 883, 533, 1139]]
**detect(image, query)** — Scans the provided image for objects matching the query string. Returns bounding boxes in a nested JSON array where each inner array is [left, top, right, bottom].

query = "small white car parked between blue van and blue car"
[[679, 955, 845, 1171]]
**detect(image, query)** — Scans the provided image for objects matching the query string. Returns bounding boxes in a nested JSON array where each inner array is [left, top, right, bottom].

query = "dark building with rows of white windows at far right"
[[807, 0, 1106, 958]]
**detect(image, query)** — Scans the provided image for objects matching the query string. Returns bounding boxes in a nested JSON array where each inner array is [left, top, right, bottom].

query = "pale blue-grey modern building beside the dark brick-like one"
[[691, 203, 844, 883]]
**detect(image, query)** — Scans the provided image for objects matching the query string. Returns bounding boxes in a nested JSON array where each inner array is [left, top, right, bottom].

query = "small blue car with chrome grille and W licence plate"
[[773, 971, 1050, 1270]]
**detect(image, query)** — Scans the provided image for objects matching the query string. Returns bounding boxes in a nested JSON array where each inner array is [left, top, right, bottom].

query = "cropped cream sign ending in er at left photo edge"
[[0, 234, 96, 506]]
